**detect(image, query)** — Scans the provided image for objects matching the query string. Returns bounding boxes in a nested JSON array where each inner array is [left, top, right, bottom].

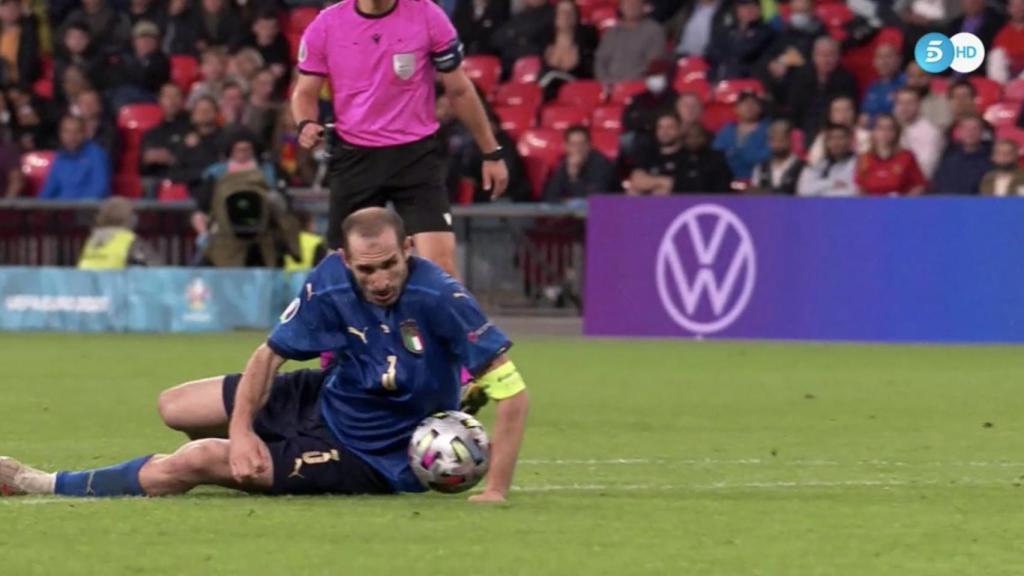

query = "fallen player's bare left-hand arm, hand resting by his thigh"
[[228, 343, 285, 483]]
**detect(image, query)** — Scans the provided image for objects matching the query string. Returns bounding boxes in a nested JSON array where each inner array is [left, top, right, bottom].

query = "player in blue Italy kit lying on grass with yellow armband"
[[0, 208, 527, 502]]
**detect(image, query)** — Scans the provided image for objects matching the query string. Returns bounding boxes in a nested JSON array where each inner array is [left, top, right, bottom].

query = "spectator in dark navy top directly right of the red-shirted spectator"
[[932, 116, 992, 195]]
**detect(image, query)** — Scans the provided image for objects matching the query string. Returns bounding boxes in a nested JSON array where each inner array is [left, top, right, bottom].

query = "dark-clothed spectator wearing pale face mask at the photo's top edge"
[[763, 0, 825, 100]]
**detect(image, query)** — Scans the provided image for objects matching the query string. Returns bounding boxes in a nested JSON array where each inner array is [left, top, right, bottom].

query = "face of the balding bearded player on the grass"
[[344, 231, 413, 306]]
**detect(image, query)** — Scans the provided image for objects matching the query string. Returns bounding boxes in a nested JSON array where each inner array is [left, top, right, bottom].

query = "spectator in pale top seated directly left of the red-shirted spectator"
[[797, 123, 860, 197]]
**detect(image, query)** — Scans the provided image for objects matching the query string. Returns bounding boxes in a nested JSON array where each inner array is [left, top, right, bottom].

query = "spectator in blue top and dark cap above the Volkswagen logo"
[[712, 92, 771, 180]]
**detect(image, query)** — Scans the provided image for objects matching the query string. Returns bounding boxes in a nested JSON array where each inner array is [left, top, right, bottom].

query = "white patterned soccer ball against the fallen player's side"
[[409, 410, 490, 494]]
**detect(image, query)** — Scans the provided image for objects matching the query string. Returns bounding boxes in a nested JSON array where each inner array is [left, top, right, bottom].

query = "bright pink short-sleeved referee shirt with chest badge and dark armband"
[[298, 0, 462, 148]]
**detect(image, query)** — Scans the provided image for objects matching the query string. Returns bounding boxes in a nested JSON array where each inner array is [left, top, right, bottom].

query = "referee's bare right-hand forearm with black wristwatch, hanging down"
[[440, 67, 509, 198]]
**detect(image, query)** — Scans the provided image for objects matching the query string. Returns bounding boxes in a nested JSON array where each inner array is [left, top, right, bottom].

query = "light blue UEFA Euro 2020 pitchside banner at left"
[[0, 268, 304, 332]]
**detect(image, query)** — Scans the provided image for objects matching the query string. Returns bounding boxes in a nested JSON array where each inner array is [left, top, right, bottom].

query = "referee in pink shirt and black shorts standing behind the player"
[[292, 0, 508, 276]]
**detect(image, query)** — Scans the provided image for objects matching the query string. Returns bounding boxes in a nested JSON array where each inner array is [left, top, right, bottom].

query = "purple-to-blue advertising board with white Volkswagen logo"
[[584, 197, 1024, 342]]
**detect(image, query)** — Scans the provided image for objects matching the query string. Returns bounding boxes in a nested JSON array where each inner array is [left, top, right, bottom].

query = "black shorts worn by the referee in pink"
[[327, 135, 452, 248]]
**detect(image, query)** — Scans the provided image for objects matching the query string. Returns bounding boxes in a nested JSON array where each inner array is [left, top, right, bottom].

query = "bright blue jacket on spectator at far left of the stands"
[[39, 141, 111, 200]]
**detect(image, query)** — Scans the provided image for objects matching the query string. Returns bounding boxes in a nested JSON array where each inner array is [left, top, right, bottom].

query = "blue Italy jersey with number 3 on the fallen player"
[[267, 254, 512, 492]]
